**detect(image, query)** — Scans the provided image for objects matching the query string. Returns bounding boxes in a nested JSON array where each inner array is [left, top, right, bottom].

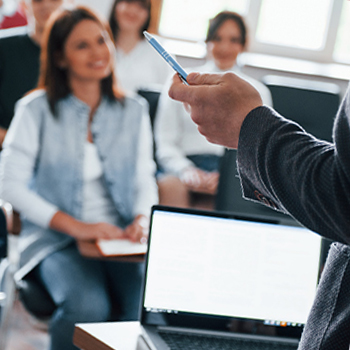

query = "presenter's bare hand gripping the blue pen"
[[169, 73, 262, 148]]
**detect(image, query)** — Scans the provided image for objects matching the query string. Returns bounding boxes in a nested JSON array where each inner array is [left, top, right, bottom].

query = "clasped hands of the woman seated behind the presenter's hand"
[[181, 167, 219, 194]]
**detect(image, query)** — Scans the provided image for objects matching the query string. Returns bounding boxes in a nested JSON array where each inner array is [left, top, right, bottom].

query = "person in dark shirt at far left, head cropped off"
[[0, 0, 64, 146]]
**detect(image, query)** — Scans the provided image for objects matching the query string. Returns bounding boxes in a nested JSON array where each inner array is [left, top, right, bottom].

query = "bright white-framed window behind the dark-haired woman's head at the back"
[[159, 0, 350, 64]]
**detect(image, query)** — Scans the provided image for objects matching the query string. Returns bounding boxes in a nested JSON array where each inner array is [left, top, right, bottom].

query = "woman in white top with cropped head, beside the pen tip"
[[109, 0, 171, 92]]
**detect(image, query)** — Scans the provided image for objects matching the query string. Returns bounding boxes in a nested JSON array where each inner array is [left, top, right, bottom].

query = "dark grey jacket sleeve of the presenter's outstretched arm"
[[237, 87, 350, 244]]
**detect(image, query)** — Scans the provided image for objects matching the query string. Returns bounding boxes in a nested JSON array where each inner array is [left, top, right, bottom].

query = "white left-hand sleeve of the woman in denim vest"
[[0, 98, 58, 227]]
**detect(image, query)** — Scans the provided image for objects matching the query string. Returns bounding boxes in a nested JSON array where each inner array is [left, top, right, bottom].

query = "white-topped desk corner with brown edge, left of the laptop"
[[73, 322, 149, 350]]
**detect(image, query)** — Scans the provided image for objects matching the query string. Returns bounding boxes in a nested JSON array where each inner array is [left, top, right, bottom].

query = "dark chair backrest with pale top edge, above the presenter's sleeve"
[[262, 75, 341, 141]]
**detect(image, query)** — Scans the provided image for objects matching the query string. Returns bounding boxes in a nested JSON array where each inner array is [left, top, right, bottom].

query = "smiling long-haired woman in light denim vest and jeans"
[[0, 7, 157, 350]]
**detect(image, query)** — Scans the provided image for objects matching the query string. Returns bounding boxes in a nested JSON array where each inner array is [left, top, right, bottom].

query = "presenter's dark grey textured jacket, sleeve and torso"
[[237, 83, 350, 350]]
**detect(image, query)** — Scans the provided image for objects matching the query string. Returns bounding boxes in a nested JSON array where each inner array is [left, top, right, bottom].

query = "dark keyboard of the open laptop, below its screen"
[[159, 331, 298, 350]]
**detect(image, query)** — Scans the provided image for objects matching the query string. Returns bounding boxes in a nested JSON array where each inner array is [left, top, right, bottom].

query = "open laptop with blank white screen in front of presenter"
[[140, 206, 322, 350]]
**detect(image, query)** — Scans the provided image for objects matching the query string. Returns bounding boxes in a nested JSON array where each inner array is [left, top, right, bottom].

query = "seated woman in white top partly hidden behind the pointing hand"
[[155, 11, 272, 209]]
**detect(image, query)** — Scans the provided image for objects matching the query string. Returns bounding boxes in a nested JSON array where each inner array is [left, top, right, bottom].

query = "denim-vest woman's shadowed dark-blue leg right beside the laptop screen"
[[106, 261, 144, 321]]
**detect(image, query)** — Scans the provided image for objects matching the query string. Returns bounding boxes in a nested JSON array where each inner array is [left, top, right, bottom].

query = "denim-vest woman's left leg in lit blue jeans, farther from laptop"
[[35, 245, 111, 350]]
